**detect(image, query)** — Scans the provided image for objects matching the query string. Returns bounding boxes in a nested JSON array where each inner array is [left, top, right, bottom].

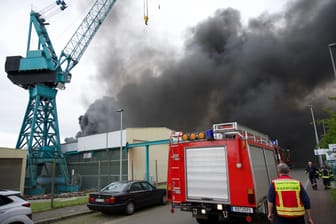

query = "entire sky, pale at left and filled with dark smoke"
[[0, 0, 336, 166]]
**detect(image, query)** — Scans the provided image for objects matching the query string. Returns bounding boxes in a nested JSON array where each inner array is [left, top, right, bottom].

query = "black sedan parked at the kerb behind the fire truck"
[[87, 181, 167, 215]]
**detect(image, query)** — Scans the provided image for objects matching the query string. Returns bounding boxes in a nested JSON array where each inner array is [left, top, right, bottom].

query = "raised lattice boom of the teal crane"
[[59, 0, 116, 75]]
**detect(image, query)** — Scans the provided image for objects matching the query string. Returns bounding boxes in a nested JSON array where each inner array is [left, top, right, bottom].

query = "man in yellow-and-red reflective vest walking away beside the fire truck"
[[268, 163, 314, 224]]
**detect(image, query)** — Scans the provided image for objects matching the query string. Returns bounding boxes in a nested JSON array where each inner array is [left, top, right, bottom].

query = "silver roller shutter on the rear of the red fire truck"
[[185, 146, 229, 203]]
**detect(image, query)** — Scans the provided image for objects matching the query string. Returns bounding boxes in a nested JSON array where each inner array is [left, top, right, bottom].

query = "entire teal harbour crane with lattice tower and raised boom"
[[5, 0, 116, 194]]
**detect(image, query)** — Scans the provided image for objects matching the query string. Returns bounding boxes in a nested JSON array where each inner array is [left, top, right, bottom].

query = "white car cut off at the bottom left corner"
[[0, 190, 33, 224]]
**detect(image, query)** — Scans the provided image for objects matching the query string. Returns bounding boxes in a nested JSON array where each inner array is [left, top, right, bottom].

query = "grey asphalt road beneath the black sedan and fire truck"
[[33, 170, 336, 224]]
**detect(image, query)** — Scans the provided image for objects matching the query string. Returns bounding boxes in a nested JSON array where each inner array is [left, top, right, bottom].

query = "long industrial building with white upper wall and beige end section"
[[62, 127, 171, 190]]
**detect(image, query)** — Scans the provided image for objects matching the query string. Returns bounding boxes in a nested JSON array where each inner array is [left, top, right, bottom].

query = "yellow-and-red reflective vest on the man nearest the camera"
[[272, 176, 305, 218]]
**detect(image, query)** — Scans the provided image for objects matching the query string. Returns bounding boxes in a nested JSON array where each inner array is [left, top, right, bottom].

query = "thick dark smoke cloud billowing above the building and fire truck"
[[72, 0, 336, 165]]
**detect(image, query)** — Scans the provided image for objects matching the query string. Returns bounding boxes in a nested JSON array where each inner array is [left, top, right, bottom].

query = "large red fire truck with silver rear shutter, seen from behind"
[[167, 122, 279, 224]]
